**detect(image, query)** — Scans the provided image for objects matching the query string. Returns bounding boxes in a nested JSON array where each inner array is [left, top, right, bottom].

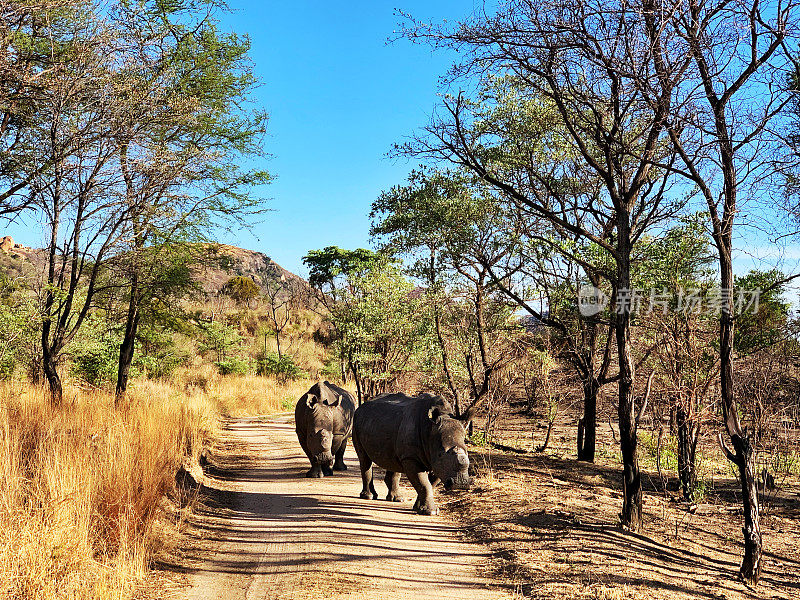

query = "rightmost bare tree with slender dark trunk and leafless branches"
[[642, 0, 798, 584]]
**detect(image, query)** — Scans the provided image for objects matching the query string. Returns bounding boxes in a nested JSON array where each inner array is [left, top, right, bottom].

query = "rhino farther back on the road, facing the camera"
[[294, 381, 356, 477]]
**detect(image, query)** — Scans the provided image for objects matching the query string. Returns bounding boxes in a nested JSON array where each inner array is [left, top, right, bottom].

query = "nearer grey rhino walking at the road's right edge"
[[353, 393, 472, 515]]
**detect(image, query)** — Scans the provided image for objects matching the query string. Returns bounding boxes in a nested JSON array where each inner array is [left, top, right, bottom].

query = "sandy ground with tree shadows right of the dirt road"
[[447, 411, 800, 600]]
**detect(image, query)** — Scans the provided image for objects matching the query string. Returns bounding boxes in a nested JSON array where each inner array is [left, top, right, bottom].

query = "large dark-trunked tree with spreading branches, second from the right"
[[401, 0, 685, 530]]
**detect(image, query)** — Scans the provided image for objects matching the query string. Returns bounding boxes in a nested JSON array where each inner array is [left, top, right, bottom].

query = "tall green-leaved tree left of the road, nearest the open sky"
[[113, 0, 269, 399]]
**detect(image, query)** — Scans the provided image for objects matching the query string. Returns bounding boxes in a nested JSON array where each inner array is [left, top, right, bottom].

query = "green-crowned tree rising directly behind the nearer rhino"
[[370, 172, 513, 414]]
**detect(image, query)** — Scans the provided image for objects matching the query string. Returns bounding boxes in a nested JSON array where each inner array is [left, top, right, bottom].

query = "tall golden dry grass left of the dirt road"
[[0, 381, 215, 600]]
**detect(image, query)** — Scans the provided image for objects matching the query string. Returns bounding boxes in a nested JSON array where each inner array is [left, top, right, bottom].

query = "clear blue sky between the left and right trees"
[[217, 0, 472, 274]]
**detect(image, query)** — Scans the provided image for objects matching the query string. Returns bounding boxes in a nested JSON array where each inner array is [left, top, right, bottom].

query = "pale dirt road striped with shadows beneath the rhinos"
[[174, 416, 512, 600]]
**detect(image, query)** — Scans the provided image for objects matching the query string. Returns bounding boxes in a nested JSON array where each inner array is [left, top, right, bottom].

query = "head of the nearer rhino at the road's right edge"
[[428, 404, 473, 490]]
